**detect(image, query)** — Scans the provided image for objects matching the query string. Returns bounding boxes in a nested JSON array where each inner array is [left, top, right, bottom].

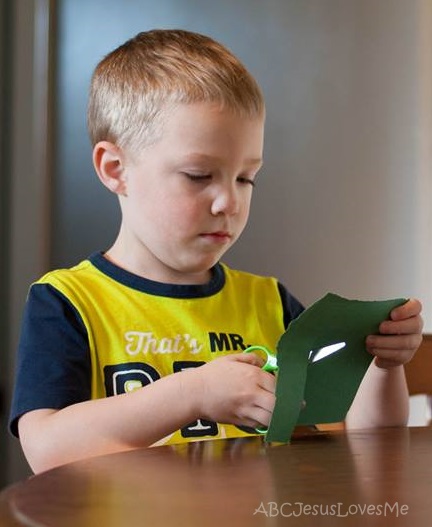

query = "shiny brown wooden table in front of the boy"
[[0, 427, 432, 527]]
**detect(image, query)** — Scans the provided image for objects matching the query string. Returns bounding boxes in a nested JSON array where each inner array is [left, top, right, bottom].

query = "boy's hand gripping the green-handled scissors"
[[189, 353, 276, 428]]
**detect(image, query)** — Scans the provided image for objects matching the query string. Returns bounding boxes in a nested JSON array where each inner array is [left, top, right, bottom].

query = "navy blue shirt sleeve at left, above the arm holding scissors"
[[9, 284, 91, 437]]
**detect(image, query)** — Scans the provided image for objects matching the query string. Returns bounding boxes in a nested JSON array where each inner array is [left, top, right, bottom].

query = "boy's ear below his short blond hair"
[[93, 141, 126, 196]]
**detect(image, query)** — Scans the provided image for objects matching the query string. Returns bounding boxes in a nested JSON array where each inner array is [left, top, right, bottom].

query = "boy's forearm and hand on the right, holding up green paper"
[[346, 300, 423, 428]]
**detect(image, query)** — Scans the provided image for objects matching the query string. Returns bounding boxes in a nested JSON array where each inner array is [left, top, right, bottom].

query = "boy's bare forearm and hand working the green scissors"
[[18, 354, 275, 472]]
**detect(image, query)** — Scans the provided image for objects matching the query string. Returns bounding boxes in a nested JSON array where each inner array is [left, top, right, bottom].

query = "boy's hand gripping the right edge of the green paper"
[[366, 299, 423, 368]]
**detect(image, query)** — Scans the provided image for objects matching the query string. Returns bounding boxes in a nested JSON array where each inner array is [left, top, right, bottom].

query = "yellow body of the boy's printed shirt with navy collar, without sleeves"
[[33, 254, 285, 444]]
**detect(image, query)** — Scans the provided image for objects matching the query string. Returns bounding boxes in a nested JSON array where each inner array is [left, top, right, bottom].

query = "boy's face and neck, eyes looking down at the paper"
[[108, 103, 264, 283]]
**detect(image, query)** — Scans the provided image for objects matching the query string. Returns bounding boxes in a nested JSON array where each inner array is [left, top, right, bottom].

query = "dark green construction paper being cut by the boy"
[[266, 293, 406, 443]]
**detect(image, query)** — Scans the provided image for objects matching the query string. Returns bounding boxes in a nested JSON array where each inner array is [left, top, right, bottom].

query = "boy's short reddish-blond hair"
[[88, 29, 264, 150]]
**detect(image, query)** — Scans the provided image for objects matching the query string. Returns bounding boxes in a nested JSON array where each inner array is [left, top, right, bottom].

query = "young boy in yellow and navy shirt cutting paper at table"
[[11, 30, 422, 472]]
